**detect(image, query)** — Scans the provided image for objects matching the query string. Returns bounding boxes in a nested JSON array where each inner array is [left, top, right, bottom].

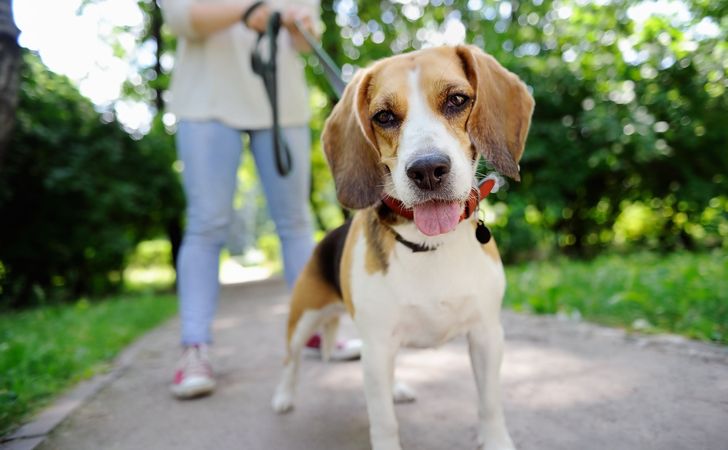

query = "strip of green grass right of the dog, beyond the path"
[[505, 251, 728, 344]]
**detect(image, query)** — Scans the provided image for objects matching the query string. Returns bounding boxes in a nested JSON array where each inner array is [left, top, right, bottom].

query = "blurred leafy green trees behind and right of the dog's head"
[[312, 0, 728, 258]]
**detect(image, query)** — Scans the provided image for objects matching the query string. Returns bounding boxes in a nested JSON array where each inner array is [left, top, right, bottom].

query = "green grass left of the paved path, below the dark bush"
[[0, 294, 177, 436]]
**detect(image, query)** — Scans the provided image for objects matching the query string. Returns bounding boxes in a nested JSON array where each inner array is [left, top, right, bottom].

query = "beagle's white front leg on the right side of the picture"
[[468, 320, 515, 450]]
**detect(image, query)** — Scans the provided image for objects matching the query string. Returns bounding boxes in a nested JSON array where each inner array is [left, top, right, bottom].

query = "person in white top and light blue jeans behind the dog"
[[160, 0, 356, 398]]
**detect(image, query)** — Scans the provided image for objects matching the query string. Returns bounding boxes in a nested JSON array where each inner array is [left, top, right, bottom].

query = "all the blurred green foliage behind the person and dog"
[[0, 0, 728, 307]]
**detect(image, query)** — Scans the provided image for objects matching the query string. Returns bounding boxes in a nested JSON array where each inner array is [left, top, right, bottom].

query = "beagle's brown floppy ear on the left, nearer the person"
[[321, 69, 384, 209]]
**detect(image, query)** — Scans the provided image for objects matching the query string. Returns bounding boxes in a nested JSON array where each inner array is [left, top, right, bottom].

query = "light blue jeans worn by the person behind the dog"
[[176, 121, 314, 345]]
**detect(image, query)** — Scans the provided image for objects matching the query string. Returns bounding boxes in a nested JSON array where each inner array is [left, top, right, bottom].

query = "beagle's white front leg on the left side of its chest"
[[360, 329, 402, 450]]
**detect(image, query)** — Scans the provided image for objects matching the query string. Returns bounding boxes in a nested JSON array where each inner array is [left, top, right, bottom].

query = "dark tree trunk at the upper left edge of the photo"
[[0, 0, 21, 165]]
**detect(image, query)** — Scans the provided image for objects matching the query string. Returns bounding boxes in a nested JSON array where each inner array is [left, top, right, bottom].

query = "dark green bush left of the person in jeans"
[[0, 53, 182, 307]]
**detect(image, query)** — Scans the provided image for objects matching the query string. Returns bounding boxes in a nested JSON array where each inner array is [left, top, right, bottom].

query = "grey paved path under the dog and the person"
[[12, 282, 728, 450]]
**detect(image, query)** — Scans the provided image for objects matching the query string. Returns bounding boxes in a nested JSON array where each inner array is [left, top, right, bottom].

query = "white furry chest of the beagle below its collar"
[[353, 224, 505, 347]]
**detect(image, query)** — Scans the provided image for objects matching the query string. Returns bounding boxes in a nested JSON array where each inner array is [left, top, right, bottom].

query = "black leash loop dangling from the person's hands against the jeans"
[[250, 11, 293, 176]]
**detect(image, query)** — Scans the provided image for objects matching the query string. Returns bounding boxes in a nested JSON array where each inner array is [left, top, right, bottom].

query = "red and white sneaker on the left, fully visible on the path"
[[170, 344, 215, 399]]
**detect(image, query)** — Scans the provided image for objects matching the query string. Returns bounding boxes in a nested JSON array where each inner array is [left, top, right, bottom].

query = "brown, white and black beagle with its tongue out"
[[272, 46, 534, 450]]
